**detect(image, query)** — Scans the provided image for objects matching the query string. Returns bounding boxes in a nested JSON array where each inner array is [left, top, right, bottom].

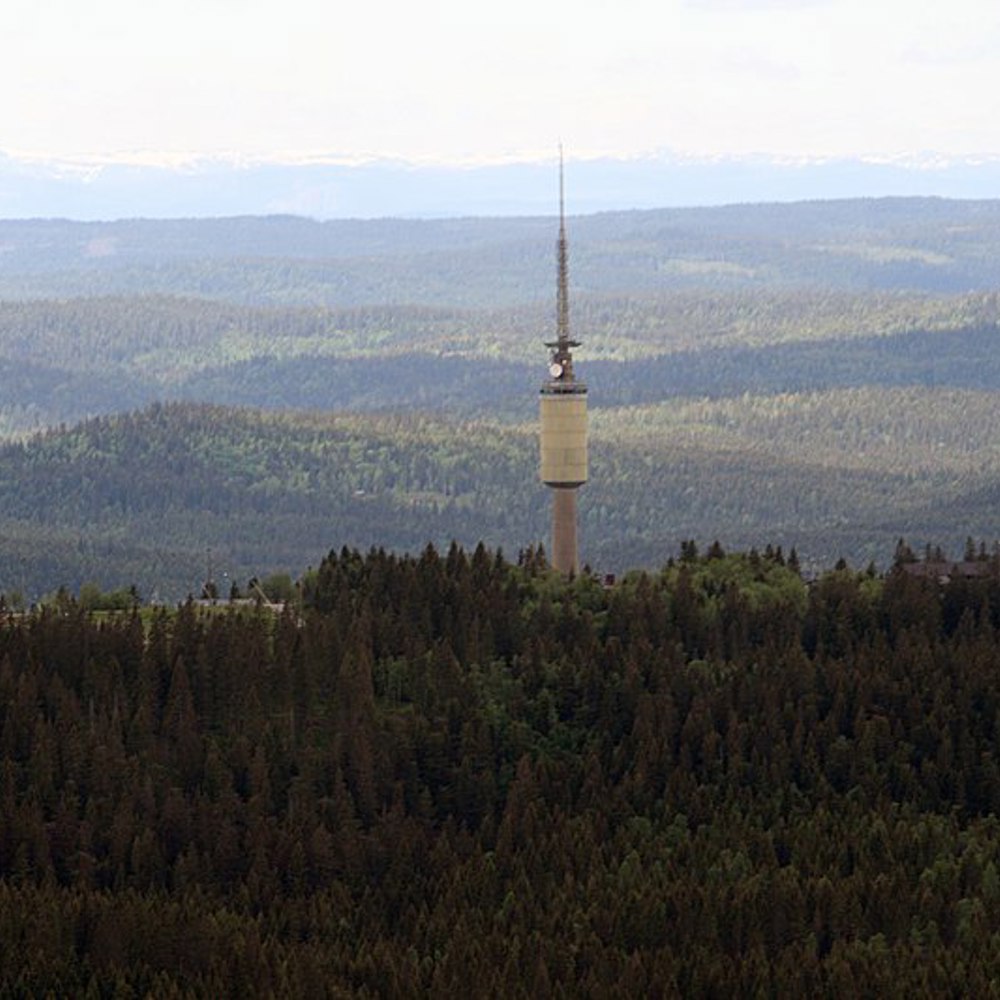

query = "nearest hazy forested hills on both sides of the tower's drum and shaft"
[[0, 398, 1000, 600]]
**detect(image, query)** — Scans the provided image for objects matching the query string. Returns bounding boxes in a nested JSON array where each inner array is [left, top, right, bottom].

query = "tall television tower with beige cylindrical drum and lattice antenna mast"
[[540, 146, 587, 576]]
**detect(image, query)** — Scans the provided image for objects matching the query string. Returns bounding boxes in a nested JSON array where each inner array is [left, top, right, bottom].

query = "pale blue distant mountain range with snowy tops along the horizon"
[[0, 155, 1000, 220]]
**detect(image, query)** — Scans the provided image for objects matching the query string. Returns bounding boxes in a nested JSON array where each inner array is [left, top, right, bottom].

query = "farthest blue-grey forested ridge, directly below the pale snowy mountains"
[[0, 198, 1000, 308]]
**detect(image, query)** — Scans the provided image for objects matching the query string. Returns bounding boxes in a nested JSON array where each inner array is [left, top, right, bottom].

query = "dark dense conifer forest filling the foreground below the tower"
[[0, 543, 1000, 997]]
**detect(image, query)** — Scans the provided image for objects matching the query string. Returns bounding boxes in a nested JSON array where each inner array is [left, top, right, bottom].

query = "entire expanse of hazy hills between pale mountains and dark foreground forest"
[[0, 199, 1000, 596]]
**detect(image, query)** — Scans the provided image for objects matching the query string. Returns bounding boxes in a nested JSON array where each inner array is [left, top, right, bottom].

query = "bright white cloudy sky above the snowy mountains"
[[0, 0, 1000, 162]]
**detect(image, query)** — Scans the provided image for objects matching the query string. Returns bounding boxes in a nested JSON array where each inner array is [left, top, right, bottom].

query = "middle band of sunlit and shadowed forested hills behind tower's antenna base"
[[0, 290, 1000, 437]]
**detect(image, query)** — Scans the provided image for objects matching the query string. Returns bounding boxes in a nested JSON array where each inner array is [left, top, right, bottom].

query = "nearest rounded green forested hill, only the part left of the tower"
[[0, 405, 542, 599]]
